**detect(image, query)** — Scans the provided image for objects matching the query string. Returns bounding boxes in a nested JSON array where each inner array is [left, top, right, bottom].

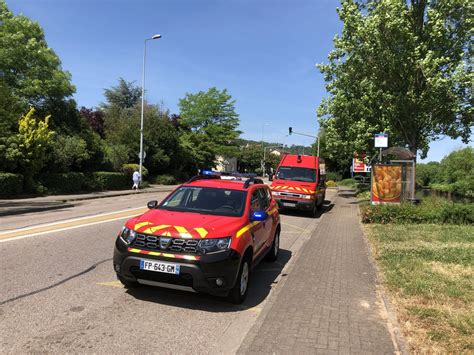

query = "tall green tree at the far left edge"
[[0, 0, 78, 132]]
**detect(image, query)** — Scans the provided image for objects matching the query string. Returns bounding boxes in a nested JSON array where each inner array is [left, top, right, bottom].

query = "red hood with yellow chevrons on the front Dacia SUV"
[[125, 209, 243, 239]]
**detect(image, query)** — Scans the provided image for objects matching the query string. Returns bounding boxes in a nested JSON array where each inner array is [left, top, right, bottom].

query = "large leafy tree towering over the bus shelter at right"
[[318, 0, 474, 159]]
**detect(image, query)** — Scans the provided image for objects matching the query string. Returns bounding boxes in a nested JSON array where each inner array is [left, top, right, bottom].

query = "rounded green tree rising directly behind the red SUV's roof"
[[179, 87, 241, 167]]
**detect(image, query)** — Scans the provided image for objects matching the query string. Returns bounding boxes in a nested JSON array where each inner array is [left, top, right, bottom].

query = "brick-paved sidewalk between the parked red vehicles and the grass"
[[238, 190, 404, 354]]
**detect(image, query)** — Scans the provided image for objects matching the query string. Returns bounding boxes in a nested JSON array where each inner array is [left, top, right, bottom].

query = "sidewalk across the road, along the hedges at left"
[[0, 185, 178, 217]]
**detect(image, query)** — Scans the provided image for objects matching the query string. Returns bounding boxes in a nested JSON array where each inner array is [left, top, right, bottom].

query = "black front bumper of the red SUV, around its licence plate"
[[114, 238, 241, 296]]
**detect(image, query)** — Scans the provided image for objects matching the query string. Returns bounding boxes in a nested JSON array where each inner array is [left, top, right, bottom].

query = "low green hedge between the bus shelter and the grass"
[[362, 198, 474, 224]]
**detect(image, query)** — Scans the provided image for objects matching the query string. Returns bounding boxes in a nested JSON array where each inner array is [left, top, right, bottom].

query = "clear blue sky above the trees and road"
[[7, 0, 472, 161]]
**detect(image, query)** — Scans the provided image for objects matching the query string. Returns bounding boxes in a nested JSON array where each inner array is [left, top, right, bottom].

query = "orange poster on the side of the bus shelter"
[[371, 165, 402, 205]]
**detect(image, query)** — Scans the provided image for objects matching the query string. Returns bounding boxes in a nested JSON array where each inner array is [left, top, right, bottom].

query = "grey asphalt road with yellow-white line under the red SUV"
[[0, 190, 335, 354]]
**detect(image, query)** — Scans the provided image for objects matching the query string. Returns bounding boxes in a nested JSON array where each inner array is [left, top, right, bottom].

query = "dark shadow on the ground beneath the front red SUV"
[[127, 249, 291, 312]]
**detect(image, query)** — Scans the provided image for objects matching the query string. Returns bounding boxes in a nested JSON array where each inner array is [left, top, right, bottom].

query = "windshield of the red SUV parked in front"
[[158, 186, 247, 217]]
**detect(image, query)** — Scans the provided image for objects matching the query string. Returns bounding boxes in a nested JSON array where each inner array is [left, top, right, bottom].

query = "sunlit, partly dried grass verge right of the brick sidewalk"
[[364, 224, 474, 353]]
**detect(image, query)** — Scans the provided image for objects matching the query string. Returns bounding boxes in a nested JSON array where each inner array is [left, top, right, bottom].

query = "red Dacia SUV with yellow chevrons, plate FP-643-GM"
[[114, 171, 280, 303]]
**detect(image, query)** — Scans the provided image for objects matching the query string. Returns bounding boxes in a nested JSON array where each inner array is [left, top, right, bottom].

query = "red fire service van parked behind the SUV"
[[272, 154, 326, 216]]
